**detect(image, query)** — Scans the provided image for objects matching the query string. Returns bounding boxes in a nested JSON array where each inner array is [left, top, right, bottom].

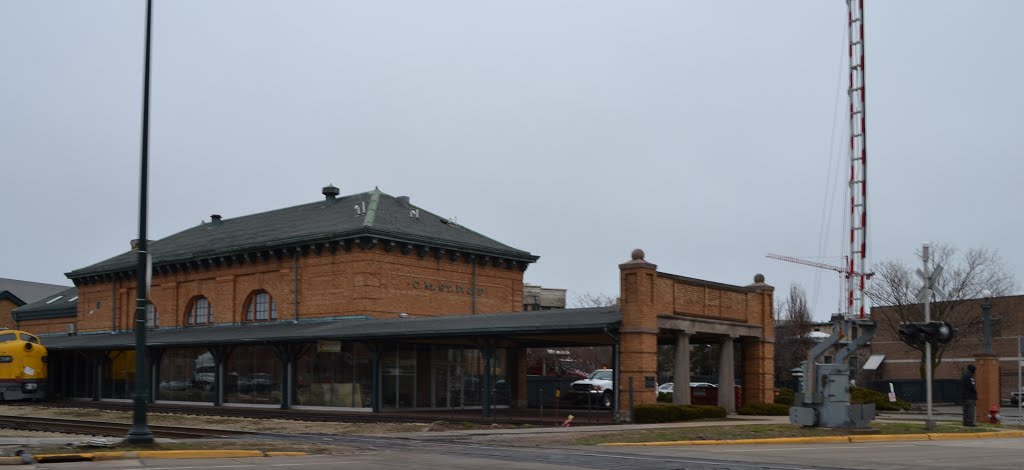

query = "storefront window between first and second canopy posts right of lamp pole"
[[157, 347, 217, 401]]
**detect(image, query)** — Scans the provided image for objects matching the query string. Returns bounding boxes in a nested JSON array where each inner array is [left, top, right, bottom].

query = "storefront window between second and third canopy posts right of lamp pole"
[[224, 346, 284, 404]]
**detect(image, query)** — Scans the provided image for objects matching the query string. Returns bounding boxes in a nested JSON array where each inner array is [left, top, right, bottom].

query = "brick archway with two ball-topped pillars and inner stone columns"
[[618, 250, 774, 419]]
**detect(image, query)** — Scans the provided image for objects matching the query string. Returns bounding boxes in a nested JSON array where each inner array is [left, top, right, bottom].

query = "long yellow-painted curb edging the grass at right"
[[598, 431, 1024, 446]]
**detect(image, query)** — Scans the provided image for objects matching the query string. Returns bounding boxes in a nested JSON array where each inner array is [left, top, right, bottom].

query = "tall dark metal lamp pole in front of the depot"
[[128, 0, 153, 444]]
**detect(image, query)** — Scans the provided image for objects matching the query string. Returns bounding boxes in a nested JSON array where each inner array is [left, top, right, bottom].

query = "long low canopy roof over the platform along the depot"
[[42, 306, 623, 351]]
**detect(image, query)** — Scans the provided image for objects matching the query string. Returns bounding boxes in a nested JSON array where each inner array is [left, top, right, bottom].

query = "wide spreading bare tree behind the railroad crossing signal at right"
[[864, 244, 1017, 377]]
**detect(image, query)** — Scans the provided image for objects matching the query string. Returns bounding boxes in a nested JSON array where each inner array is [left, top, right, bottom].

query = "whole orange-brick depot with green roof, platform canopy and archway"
[[13, 186, 773, 417]]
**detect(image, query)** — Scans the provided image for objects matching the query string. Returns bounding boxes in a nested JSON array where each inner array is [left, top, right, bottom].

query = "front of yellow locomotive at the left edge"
[[0, 330, 46, 401]]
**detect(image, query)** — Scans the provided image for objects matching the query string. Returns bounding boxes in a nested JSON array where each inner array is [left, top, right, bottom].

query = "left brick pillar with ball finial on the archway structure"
[[615, 249, 657, 421]]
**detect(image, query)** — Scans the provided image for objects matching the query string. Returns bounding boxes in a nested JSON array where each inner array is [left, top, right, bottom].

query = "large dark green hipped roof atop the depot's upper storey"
[[67, 189, 538, 280]]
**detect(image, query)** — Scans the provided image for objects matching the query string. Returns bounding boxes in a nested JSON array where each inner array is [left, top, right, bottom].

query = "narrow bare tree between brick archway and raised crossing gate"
[[775, 284, 814, 389]]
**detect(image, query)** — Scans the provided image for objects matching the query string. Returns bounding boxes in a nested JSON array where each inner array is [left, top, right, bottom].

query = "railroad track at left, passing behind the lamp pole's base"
[[0, 416, 250, 439]]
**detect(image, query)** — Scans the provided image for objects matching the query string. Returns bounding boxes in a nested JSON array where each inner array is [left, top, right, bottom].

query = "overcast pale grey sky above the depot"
[[0, 0, 1024, 319]]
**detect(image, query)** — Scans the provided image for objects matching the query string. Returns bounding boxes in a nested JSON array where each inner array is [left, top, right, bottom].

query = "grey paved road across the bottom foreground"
[[28, 439, 1024, 470]]
